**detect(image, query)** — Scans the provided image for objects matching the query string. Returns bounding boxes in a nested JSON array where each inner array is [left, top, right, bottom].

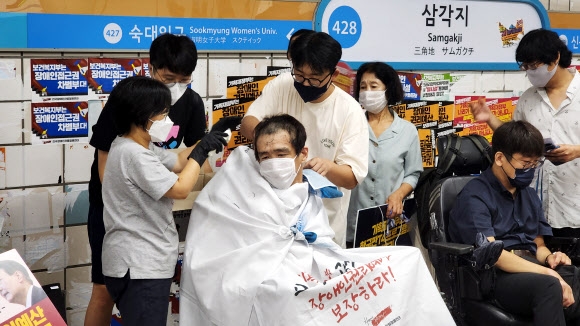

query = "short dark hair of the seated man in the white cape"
[[254, 114, 306, 161]]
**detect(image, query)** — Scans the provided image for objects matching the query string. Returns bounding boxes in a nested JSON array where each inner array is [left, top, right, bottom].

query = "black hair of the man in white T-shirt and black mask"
[[290, 32, 342, 74]]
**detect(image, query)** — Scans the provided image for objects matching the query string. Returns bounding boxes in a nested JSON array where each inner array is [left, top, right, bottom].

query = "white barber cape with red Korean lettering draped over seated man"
[[180, 146, 455, 326]]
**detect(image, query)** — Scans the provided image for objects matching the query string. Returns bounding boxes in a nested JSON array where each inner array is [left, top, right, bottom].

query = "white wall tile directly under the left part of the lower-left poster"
[[23, 145, 63, 186]]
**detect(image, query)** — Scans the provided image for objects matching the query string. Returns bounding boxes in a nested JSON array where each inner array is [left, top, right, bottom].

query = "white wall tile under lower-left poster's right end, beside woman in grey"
[[64, 144, 95, 183]]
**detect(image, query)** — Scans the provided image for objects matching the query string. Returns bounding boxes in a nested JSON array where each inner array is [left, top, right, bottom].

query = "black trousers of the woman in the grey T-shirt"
[[105, 271, 172, 326]]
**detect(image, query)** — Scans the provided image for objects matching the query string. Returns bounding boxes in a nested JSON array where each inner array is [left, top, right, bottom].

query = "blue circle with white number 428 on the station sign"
[[328, 6, 362, 49]]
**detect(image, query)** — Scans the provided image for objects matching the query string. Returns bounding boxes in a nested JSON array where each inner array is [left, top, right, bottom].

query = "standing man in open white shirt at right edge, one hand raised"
[[471, 29, 580, 237]]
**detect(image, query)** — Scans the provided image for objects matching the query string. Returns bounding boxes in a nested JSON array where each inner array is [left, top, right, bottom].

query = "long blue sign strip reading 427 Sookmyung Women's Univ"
[[0, 13, 312, 51]]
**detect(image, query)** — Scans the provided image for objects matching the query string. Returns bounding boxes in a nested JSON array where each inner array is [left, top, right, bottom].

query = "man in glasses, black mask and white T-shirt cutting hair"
[[240, 32, 374, 248]]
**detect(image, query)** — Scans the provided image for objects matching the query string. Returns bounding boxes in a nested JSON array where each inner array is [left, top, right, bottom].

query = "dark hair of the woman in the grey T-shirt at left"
[[108, 76, 171, 135]]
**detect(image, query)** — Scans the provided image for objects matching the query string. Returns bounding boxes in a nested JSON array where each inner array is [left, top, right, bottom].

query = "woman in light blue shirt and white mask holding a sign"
[[347, 62, 423, 247]]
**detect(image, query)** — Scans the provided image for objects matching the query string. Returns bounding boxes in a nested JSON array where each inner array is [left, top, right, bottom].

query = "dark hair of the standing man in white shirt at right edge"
[[516, 28, 572, 68]]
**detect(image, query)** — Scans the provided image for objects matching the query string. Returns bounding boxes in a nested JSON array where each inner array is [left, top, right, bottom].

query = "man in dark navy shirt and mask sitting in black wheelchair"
[[448, 121, 580, 326]]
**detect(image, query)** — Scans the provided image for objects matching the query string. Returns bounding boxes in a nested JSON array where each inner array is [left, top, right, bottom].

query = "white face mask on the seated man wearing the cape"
[[260, 155, 300, 189]]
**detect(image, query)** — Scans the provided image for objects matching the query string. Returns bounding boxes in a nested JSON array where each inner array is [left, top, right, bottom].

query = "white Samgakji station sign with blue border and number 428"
[[314, 0, 549, 70]]
